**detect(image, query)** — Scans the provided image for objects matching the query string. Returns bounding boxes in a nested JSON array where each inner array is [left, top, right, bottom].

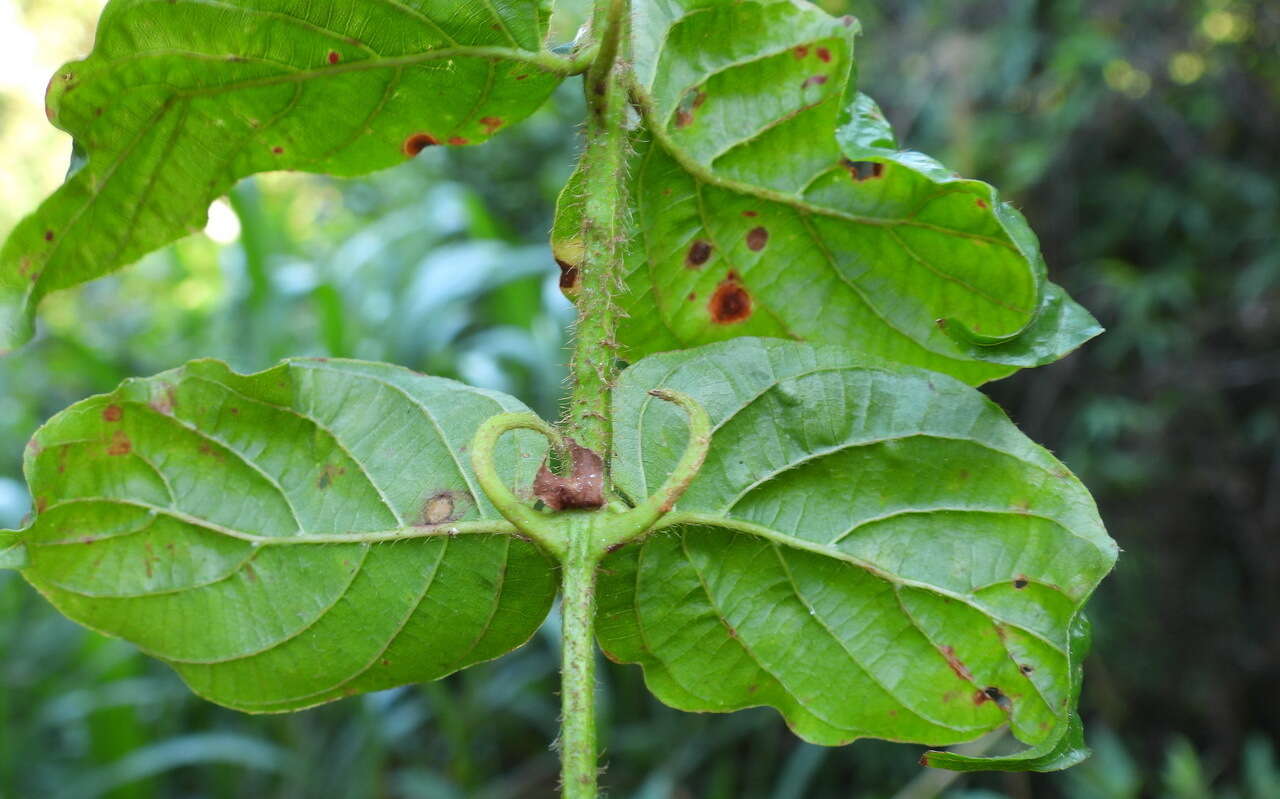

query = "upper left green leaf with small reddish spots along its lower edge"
[[0, 0, 568, 351]]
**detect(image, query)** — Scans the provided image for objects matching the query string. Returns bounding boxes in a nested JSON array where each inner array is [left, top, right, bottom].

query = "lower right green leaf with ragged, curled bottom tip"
[[599, 338, 1116, 767]]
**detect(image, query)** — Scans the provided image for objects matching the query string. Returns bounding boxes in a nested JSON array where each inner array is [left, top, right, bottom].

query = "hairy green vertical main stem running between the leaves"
[[561, 0, 627, 799]]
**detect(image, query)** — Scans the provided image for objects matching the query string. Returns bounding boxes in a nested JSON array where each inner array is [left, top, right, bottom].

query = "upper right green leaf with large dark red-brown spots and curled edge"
[[554, 0, 1101, 384]]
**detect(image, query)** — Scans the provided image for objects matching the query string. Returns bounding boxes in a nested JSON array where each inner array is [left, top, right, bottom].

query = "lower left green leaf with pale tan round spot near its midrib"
[[6, 360, 556, 712]]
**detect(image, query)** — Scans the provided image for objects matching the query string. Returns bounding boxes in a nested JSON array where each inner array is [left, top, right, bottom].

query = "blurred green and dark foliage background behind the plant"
[[0, 0, 1280, 799]]
